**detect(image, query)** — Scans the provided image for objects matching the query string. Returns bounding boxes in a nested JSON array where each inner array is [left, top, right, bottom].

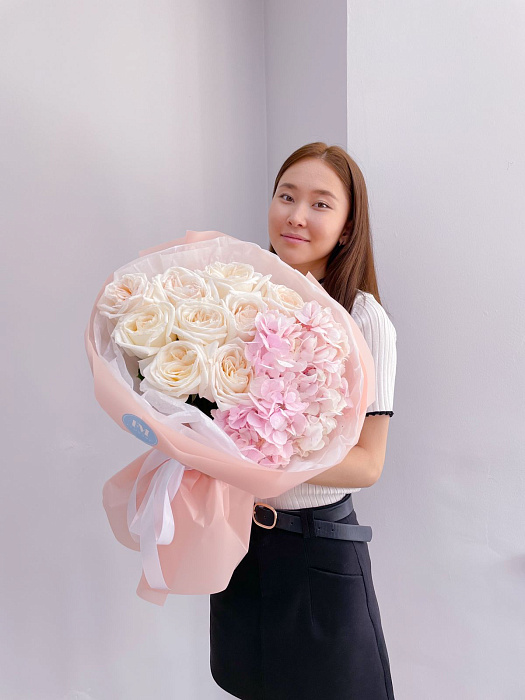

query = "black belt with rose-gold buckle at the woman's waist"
[[252, 493, 372, 542]]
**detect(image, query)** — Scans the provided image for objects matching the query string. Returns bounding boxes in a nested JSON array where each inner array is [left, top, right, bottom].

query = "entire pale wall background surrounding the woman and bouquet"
[[0, 0, 525, 700]]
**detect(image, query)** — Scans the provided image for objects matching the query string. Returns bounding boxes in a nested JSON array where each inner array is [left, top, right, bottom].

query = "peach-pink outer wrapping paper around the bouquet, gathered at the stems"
[[85, 231, 375, 605]]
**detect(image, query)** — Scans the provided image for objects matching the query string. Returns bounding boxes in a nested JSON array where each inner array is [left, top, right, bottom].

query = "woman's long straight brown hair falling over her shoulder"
[[269, 141, 381, 312]]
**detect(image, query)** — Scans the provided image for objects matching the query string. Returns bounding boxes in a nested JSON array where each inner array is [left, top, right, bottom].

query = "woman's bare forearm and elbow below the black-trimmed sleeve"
[[306, 415, 390, 488]]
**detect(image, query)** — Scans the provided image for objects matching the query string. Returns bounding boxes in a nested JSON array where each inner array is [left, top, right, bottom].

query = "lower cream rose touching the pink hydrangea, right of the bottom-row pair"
[[210, 339, 253, 411]]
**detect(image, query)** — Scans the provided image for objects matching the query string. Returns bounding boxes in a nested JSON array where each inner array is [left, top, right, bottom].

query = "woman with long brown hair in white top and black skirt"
[[210, 143, 397, 700]]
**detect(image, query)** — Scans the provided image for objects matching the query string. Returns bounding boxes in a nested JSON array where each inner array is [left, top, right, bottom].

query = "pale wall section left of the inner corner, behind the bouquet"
[[0, 0, 267, 700]]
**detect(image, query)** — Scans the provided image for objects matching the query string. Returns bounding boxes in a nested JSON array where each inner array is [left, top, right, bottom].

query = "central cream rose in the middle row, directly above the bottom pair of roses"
[[173, 300, 237, 345]]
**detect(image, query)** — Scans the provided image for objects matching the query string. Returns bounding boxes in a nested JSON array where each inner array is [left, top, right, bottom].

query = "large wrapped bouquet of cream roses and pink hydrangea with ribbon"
[[86, 231, 374, 605]]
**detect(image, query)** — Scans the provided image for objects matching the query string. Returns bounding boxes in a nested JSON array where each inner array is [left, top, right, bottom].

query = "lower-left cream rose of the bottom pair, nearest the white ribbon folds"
[[139, 340, 214, 401]]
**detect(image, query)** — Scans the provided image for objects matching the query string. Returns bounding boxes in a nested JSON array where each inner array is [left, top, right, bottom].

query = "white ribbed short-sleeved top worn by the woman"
[[254, 290, 397, 510]]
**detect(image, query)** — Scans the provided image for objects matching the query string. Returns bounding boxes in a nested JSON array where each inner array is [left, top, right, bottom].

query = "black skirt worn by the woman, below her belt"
[[210, 494, 394, 700]]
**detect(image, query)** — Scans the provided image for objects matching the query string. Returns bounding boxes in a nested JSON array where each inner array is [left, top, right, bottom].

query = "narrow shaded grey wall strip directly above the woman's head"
[[264, 0, 347, 203]]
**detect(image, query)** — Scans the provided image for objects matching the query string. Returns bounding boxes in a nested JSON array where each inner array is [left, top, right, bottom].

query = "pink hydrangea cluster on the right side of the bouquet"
[[212, 301, 351, 468]]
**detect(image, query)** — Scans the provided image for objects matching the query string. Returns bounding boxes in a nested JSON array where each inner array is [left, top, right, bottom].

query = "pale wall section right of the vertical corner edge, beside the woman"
[[348, 0, 525, 700]]
